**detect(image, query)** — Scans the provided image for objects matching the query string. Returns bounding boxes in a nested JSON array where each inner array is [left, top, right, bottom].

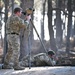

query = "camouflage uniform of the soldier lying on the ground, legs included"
[[20, 53, 56, 66]]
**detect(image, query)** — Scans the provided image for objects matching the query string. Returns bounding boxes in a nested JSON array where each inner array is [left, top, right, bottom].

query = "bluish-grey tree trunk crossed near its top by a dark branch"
[[56, 0, 62, 48]]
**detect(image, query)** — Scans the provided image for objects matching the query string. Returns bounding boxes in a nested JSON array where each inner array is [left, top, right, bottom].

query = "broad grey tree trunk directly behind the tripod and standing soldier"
[[20, 0, 34, 59]]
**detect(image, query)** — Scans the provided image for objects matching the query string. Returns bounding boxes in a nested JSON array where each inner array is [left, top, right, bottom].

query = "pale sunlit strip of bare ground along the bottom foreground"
[[0, 66, 75, 75]]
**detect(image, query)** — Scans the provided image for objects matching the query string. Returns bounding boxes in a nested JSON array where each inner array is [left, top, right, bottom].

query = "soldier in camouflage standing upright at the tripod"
[[3, 7, 26, 70]]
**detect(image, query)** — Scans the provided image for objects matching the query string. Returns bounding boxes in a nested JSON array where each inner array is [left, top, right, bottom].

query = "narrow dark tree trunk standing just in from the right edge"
[[66, 0, 72, 54]]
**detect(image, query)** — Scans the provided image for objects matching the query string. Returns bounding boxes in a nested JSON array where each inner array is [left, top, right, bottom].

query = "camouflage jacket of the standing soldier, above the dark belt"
[[6, 14, 26, 34]]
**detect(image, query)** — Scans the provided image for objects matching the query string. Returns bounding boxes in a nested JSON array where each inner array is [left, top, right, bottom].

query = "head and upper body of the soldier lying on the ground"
[[34, 50, 56, 66]]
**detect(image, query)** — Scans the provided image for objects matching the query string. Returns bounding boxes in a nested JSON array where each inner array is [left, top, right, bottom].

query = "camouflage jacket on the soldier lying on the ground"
[[34, 53, 55, 66]]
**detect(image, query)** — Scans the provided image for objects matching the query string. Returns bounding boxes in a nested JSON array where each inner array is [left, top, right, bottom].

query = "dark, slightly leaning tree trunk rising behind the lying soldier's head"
[[48, 0, 57, 52]]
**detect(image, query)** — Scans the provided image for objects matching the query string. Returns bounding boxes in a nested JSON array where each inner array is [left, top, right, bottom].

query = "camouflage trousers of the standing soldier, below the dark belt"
[[4, 34, 20, 66]]
